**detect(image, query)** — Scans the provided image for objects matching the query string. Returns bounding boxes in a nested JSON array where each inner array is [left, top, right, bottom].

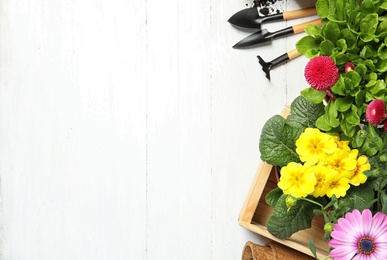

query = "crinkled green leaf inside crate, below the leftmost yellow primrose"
[[267, 194, 317, 239]]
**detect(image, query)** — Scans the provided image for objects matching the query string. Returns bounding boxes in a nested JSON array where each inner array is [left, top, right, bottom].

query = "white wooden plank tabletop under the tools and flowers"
[[0, 0, 311, 260]]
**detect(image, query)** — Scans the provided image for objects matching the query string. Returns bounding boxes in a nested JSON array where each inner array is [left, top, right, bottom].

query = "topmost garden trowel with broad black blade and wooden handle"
[[228, 7, 317, 29]]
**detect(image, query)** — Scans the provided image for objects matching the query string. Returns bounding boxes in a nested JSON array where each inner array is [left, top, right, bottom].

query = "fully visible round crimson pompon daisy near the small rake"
[[304, 56, 339, 91]]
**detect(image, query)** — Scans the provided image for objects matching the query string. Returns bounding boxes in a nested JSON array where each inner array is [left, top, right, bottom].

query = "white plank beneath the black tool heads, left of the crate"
[[211, 0, 286, 259]]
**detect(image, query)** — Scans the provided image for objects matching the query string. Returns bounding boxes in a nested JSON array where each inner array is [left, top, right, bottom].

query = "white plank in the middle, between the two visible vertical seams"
[[148, 1, 211, 259]]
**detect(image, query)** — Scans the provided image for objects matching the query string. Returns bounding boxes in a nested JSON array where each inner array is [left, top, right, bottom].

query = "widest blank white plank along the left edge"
[[0, 0, 146, 259]]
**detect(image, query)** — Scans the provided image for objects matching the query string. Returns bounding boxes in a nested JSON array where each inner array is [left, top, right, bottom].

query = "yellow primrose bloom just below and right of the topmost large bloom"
[[327, 149, 357, 179]]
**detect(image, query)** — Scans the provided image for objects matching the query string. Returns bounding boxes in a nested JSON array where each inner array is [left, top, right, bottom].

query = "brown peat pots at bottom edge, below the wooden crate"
[[242, 241, 314, 260]]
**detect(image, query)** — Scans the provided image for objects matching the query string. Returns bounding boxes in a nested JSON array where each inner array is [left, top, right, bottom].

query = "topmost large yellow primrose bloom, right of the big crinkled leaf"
[[296, 128, 337, 165]]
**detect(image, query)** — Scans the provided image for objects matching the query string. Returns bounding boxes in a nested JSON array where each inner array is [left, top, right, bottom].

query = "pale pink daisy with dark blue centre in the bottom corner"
[[329, 209, 387, 260]]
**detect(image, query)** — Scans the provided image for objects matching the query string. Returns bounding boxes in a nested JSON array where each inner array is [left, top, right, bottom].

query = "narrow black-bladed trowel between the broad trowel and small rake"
[[233, 18, 321, 48]]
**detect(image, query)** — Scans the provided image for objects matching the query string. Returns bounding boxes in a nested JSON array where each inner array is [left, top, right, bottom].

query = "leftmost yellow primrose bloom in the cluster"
[[278, 162, 317, 198]]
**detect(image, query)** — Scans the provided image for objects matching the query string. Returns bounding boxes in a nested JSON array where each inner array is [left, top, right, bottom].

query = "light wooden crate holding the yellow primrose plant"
[[239, 107, 329, 258]]
